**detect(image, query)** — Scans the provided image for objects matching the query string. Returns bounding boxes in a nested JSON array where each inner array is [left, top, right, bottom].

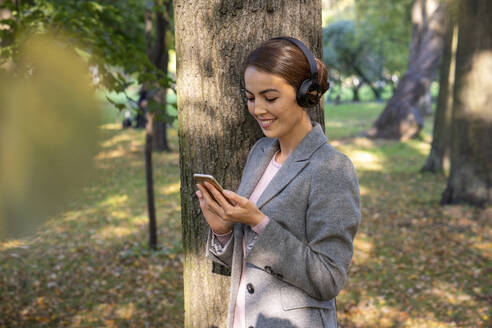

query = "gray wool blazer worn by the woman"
[[206, 122, 360, 328]]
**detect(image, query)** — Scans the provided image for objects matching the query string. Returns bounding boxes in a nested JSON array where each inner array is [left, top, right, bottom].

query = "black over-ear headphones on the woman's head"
[[272, 36, 322, 107]]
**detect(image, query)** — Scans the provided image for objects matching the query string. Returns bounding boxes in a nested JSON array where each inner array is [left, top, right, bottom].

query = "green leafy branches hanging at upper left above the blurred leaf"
[[0, 0, 173, 126]]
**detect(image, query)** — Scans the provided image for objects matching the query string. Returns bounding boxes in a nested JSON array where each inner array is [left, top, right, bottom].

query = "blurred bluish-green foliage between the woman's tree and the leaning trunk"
[[323, 0, 412, 101]]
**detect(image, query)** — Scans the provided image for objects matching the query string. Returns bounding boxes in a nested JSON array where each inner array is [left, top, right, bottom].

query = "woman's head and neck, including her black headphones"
[[244, 38, 329, 163]]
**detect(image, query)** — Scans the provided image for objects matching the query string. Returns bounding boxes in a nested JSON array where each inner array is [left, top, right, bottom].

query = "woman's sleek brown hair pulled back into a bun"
[[243, 39, 330, 94]]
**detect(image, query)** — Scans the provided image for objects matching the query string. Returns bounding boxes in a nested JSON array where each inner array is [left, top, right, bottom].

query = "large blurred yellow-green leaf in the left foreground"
[[0, 36, 101, 239]]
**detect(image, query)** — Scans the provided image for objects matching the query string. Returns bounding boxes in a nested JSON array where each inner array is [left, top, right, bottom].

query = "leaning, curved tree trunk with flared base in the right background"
[[367, 0, 445, 140]]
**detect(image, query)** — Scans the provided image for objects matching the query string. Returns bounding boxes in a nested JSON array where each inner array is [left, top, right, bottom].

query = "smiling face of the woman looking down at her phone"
[[244, 66, 308, 139]]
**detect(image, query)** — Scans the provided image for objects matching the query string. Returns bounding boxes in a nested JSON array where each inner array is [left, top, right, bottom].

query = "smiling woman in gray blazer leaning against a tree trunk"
[[197, 38, 360, 328]]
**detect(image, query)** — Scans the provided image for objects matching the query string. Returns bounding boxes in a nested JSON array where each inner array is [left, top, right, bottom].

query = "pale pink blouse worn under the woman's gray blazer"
[[214, 152, 282, 328]]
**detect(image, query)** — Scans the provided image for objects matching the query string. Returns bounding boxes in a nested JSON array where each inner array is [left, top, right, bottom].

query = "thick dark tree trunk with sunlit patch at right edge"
[[442, 0, 492, 206]]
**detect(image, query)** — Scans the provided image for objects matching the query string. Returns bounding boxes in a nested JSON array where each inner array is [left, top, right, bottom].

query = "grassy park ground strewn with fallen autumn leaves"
[[0, 104, 492, 327]]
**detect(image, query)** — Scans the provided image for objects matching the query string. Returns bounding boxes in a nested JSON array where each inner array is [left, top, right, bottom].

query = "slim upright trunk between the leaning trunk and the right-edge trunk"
[[421, 22, 458, 173]]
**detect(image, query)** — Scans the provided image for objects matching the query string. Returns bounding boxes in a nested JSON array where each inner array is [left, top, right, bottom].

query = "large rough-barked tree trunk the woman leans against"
[[174, 0, 324, 328]]
